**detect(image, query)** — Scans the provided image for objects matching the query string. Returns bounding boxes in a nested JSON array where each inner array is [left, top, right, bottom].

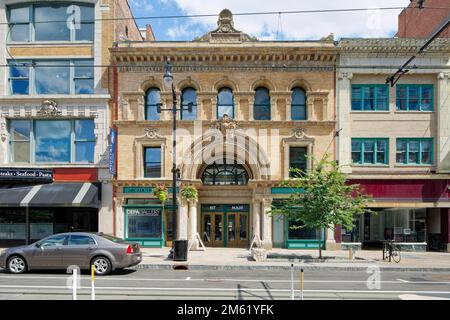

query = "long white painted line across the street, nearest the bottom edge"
[[0, 286, 450, 295]]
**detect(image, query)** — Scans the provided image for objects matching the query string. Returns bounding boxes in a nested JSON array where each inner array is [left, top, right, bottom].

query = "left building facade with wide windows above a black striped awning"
[[0, 0, 141, 245]]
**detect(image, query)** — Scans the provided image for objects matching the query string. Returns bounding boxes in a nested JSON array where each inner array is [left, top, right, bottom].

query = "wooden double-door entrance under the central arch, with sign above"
[[201, 205, 249, 248]]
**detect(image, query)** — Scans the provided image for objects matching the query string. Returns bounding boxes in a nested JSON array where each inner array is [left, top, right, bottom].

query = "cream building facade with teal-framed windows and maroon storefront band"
[[336, 38, 450, 251]]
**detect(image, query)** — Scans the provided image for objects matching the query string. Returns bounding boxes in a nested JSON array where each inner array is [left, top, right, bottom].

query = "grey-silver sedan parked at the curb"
[[0, 232, 142, 275]]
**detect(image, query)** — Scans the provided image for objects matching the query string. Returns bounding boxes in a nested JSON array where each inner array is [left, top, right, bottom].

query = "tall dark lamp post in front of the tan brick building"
[[157, 60, 193, 259]]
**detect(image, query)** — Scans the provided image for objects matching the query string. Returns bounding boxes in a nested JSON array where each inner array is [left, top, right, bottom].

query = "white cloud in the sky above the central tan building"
[[159, 0, 410, 40]]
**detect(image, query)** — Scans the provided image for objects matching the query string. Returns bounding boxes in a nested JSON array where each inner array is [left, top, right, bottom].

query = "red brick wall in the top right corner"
[[397, 0, 450, 38]]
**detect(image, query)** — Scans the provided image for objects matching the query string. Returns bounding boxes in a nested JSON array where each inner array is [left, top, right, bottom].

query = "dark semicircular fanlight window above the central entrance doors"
[[202, 161, 249, 186]]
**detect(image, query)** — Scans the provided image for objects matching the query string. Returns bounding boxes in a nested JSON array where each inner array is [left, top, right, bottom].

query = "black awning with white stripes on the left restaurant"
[[0, 183, 100, 208]]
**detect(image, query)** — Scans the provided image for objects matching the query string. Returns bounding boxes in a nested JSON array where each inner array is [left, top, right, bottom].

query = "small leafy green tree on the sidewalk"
[[272, 157, 371, 259]]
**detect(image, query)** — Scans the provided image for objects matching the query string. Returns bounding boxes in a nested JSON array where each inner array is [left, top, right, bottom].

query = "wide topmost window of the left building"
[[8, 1, 94, 42]]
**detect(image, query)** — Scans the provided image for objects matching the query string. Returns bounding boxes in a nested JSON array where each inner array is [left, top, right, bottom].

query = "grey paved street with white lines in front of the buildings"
[[0, 269, 450, 300]]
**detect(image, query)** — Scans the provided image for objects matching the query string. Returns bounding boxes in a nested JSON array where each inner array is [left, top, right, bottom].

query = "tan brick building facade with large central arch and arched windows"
[[112, 10, 337, 249]]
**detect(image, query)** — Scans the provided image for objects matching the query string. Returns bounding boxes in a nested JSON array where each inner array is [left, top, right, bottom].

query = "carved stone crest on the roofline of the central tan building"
[[194, 9, 258, 43]]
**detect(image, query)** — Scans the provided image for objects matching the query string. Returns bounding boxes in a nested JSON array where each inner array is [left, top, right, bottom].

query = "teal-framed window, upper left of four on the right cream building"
[[352, 84, 389, 111]]
